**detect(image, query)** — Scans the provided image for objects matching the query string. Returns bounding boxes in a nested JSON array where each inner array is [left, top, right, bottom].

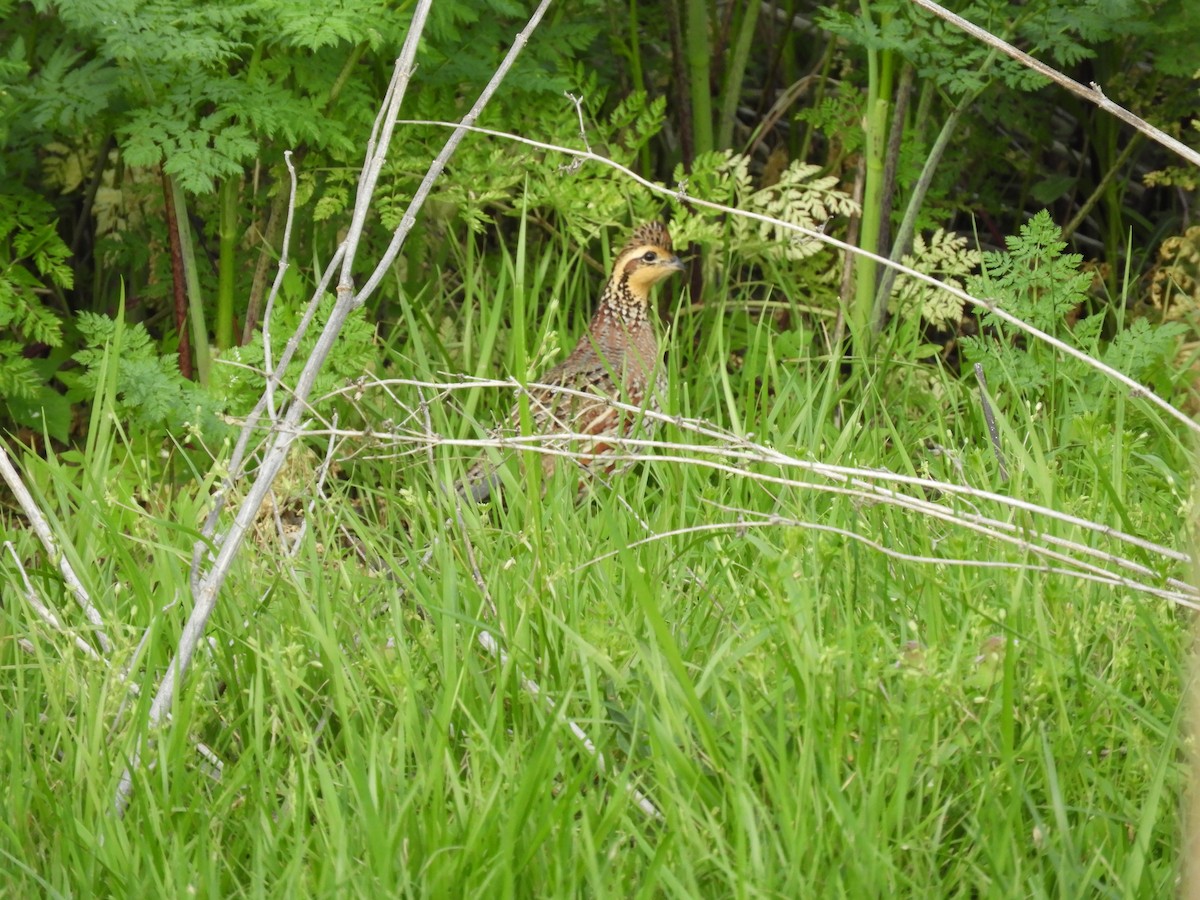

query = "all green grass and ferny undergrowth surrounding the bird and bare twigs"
[[0, 2, 1196, 896]]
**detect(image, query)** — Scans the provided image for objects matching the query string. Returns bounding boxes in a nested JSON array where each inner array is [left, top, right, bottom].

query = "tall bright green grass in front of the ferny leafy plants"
[[0, 220, 1187, 898]]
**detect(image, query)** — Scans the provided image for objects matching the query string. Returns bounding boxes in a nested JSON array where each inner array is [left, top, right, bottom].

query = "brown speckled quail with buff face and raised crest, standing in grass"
[[464, 222, 683, 503]]
